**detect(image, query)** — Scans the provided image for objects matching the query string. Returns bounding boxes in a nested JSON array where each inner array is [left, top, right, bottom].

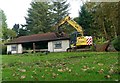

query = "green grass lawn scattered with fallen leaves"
[[2, 52, 120, 81]]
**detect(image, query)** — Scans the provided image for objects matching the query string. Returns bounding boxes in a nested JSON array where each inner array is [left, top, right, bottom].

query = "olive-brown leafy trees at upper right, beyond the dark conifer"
[[82, 2, 119, 40]]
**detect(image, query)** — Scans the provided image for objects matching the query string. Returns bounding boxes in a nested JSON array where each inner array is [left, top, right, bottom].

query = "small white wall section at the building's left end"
[[7, 44, 23, 54]]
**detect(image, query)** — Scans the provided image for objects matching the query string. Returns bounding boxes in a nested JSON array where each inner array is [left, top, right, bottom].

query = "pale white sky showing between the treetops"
[[0, 0, 86, 28]]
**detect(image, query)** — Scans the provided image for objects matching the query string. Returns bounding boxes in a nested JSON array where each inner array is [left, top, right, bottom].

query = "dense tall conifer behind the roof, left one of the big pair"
[[25, 2, 51, 34]]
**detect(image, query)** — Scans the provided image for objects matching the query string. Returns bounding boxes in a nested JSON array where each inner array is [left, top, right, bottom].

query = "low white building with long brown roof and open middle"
[[6, 32, 70, 54]]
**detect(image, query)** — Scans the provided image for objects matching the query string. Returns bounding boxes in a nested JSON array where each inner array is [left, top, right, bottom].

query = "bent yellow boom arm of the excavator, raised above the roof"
[[57, 16, 83, 36]]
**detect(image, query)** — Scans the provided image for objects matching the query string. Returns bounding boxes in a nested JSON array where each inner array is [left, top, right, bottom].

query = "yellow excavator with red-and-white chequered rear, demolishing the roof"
[[55, 16, 93, 51]]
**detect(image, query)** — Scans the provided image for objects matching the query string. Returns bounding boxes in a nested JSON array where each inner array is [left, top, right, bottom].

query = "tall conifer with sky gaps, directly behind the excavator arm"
[[52, 0, 73, 34]]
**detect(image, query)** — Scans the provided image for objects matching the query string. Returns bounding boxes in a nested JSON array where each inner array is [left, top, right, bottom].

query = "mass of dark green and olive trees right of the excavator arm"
[[77, 2, 119, 40]]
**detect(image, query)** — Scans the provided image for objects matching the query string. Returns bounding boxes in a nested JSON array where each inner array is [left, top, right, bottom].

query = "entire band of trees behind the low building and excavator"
[[0, 0, 120, 53]]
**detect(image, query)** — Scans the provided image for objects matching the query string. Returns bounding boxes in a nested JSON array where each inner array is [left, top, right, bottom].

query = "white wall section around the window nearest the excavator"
[[48, 40, 69, 52]]
